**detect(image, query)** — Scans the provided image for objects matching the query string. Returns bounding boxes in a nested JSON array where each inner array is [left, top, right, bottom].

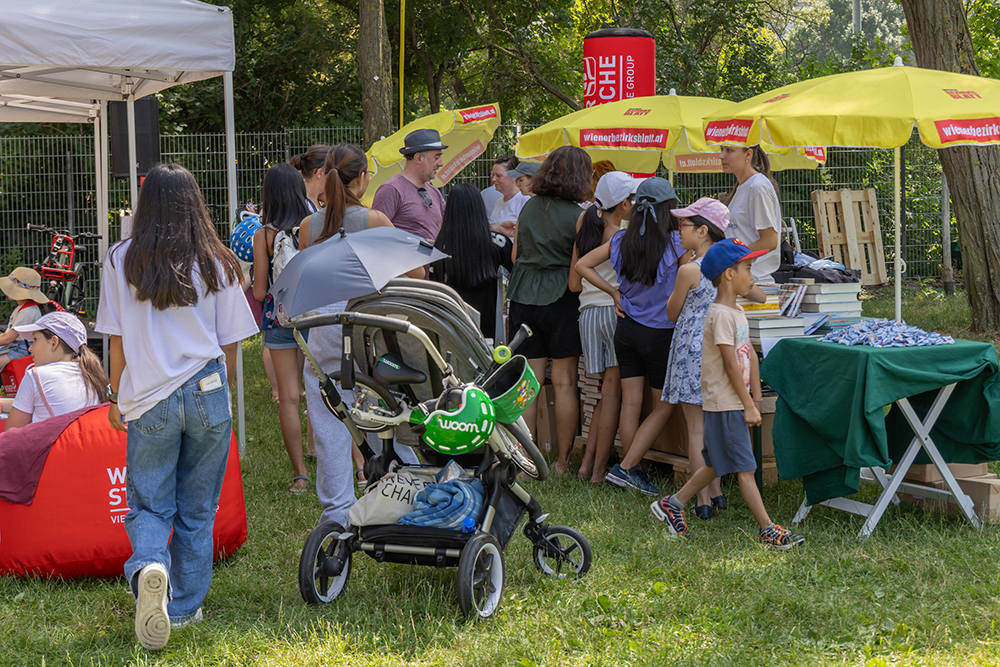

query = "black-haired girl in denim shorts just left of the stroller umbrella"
[[253, 163, 309, 493]]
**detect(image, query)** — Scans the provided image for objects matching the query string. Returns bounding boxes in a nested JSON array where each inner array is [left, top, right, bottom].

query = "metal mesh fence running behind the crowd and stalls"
[[0, 125, 957, 316]]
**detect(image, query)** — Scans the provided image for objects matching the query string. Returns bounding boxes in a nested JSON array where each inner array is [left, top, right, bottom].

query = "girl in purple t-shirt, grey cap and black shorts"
[[576, 178, 690, 495]]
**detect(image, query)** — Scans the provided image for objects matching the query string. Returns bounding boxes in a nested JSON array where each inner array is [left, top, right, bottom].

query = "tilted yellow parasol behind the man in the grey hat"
[[363, 104, 500, 206]]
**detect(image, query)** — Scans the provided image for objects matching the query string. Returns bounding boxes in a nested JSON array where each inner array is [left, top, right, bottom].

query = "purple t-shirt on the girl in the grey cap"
[[611, 229, 684, 329]]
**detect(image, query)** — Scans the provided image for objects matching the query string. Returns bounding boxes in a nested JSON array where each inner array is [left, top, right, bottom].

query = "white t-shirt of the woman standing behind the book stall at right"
[[726, 173, 781, 283]]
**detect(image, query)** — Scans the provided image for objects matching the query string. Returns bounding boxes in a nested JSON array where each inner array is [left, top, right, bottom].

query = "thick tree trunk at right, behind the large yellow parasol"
[[903, 0, 1000, 332]]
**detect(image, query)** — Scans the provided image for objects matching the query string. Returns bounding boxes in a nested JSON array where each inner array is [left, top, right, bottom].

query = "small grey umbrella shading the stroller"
[[269, 227, 448, 317]]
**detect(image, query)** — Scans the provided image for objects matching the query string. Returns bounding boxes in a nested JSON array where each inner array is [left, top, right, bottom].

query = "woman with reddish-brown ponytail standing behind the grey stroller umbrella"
[[299, 144, 424, 526]]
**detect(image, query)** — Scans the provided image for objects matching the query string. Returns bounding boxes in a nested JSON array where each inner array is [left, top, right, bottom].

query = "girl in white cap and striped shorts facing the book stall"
[[569, 171, 636, 486]]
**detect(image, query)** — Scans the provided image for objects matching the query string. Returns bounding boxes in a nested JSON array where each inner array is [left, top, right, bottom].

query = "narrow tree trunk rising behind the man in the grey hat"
[[358, 0, 392, 150]]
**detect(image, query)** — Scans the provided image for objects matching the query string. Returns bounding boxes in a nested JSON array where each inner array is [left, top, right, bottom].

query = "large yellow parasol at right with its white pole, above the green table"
[[704, 57, 1000, 320]]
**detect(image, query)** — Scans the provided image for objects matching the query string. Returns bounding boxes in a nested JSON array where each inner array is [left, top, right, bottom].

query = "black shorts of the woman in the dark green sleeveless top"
[[508, 289, 583, 359]]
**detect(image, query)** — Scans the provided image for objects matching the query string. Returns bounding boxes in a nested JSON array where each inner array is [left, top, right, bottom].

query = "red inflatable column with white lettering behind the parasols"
[[583, 28, 656, 107]]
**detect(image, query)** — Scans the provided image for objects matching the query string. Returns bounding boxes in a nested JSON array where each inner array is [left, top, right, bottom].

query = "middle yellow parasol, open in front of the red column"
[[516, 89, 826, 174]]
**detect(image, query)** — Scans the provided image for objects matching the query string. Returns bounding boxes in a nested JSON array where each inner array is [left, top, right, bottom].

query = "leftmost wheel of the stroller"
[[299, 521, 352, 604]]
